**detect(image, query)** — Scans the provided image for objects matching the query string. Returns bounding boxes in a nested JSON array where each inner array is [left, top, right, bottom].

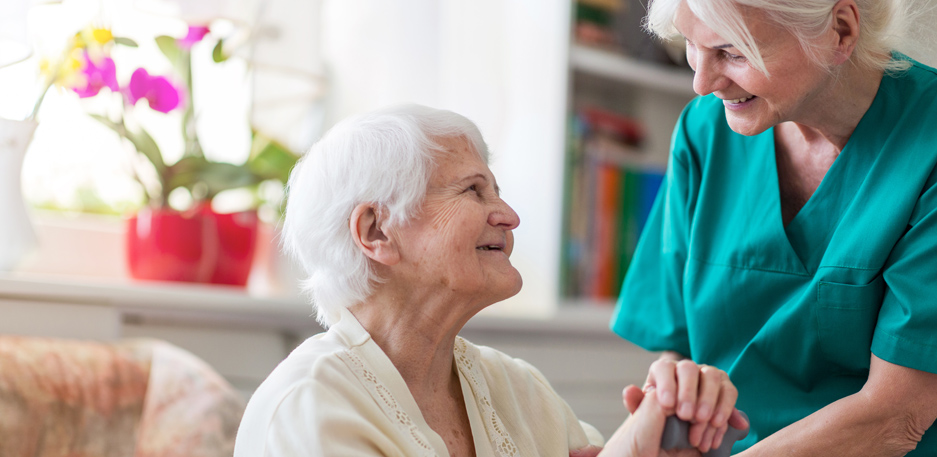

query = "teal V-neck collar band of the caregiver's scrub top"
[[764, 69, 889, 273]]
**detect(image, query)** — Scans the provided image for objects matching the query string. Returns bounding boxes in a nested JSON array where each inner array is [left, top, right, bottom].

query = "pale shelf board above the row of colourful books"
[[569, 44, 695, 96]]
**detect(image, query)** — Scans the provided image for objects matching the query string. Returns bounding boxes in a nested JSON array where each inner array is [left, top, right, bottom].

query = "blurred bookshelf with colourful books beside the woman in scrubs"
[[559, 0, 695, 307]]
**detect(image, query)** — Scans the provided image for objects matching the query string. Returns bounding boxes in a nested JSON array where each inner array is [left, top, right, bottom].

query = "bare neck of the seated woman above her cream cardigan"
[[350, 296, 471, 398]]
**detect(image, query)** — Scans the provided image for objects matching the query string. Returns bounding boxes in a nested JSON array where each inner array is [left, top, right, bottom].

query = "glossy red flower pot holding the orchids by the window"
[[127, 205, 257, 286]]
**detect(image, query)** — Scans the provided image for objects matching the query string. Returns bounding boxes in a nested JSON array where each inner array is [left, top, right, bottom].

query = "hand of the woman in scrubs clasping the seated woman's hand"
[[625, 353, 748, 452]]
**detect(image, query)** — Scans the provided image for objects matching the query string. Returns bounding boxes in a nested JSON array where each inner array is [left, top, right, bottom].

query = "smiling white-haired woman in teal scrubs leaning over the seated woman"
[[611, 0, 937, 457]]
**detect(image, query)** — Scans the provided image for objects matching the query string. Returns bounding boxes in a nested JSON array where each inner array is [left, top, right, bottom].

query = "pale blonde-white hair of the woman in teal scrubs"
[[645, 0, 919, 76]]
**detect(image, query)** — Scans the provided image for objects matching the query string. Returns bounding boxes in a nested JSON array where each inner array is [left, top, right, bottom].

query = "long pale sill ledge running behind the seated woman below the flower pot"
[[0, 273, 612, 336]]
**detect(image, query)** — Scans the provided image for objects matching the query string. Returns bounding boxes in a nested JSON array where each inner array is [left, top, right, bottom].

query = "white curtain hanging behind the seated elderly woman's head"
[[322, 0, 571, 315]]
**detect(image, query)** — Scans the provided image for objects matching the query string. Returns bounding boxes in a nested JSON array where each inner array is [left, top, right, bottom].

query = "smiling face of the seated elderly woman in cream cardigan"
[[384, 138, 521, 304]]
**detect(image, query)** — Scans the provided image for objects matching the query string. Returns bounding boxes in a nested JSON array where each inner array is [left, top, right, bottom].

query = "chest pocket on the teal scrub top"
[[817, 276, 885, 372]]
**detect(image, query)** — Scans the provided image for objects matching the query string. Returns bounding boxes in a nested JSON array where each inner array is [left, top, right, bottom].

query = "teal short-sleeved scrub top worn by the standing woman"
[[611, 55, 937, 456]]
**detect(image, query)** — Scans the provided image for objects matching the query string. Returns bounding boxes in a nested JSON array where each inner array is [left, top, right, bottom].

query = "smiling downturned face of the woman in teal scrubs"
[[674, 2, 833, 135]]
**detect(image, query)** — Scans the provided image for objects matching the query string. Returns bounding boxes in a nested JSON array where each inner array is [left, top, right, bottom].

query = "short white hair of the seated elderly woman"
[[282, 105, 488, 328]]
